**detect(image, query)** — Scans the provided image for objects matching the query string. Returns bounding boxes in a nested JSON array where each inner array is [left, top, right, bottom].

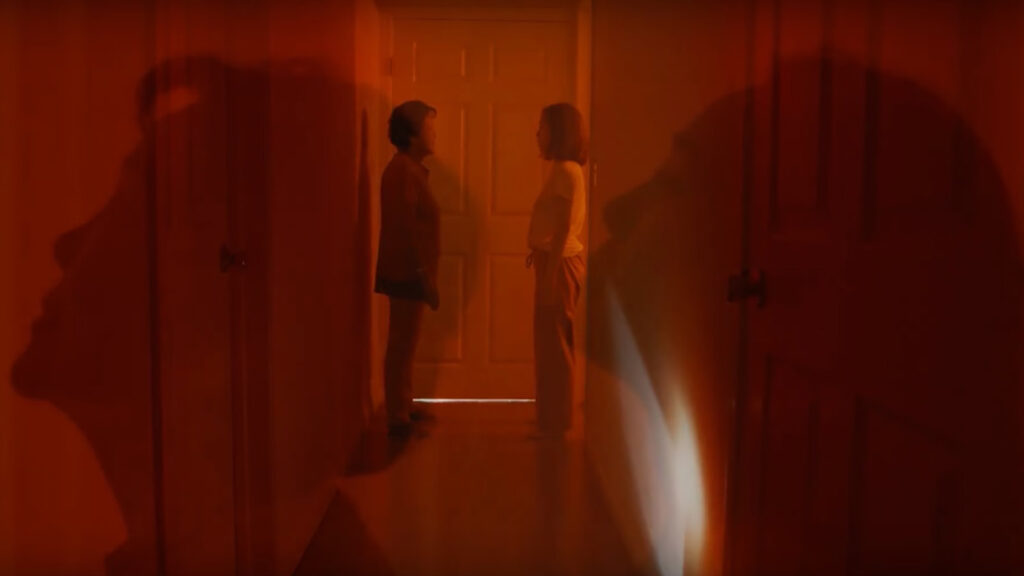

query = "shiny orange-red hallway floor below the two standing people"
[[297, 404, 636, 576]]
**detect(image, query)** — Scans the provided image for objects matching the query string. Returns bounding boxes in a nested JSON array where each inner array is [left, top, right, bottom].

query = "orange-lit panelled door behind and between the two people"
[[385, 14, 575, 398]]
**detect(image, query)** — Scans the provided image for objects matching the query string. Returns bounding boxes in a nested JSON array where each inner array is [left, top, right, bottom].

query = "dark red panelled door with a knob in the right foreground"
[[733, 0, 1024, 574]]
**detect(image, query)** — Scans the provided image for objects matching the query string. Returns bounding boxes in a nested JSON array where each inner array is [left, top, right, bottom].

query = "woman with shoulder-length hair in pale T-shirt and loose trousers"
[[527, 102, 587, 437]]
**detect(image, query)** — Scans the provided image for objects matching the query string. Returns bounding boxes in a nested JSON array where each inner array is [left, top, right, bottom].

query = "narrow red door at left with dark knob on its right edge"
[[148, 54, 236, 574]]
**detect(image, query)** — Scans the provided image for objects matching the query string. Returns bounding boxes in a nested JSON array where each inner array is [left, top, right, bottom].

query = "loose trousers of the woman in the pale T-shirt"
[[531, 251, 585, 433]]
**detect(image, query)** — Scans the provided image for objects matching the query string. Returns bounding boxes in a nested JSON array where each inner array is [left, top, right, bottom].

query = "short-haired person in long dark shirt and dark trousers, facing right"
[[374, 100, 440, 437]]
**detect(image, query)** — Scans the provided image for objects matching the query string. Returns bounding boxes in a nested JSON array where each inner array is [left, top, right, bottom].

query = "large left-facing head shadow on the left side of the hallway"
[[11, 56, 391, 575]]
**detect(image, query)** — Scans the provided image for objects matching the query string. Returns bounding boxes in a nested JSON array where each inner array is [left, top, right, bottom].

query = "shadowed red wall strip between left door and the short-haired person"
[[260, 0, 366, 574]]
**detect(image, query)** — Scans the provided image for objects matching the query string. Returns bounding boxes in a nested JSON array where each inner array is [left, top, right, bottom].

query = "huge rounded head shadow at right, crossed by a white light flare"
[[587, 58, 1024, 573]]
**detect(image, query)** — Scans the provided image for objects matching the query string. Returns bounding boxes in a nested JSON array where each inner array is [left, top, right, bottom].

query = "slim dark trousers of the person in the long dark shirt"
[[384, 297, 425, 424]]
